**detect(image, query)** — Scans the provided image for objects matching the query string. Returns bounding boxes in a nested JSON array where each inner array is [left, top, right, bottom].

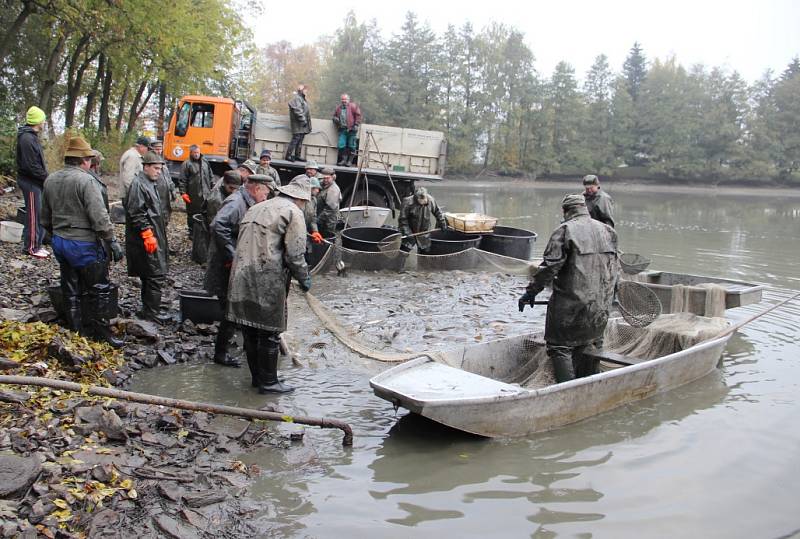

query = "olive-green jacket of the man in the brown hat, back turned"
[[40, 165, 114, 242]]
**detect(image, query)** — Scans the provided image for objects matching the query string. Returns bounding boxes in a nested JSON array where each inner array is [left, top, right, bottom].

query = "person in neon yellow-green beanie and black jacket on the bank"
[[17, 107, 50, 258]]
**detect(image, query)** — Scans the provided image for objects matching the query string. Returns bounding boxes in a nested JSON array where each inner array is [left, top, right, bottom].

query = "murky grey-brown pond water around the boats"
[[134, 185, 800, 538]]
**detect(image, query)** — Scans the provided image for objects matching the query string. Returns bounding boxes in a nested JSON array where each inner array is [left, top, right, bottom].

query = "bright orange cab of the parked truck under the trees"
[[164, 95, 256, 178]]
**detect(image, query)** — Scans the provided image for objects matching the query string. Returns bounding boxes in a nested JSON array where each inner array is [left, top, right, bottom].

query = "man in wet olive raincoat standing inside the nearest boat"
[[519, 195, 619, 383]]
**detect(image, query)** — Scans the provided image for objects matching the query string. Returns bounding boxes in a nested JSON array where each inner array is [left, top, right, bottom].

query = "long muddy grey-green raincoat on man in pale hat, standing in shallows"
[[226, 195, 308, 332]]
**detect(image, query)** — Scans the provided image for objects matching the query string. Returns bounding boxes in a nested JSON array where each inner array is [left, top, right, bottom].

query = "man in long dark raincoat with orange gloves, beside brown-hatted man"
[[122, 152, 170, 324]]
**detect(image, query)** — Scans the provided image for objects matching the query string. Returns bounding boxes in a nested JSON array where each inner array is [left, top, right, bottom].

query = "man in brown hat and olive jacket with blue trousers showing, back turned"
[[41, 133, 123, 348]]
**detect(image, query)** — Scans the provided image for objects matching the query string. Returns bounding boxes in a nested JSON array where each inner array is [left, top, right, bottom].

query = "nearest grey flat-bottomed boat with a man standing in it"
[[370, 316, 731, 437]]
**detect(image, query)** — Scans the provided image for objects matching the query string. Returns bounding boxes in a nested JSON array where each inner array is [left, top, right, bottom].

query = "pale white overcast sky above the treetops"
[[252, 0, 800, 82]]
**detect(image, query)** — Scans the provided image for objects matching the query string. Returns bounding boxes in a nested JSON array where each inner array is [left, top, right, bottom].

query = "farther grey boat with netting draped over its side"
[[635, 271, 764, 315]]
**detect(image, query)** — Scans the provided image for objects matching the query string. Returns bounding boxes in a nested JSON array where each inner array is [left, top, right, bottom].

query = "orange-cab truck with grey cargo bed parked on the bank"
[[164, 95, 447, 209]]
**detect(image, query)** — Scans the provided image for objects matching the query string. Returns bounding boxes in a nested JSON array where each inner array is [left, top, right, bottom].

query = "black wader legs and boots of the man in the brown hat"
[[59, 260, 122, 347]]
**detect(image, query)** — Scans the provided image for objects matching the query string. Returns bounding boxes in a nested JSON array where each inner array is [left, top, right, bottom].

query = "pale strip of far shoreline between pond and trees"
[[436, 176, 800, 198]]
